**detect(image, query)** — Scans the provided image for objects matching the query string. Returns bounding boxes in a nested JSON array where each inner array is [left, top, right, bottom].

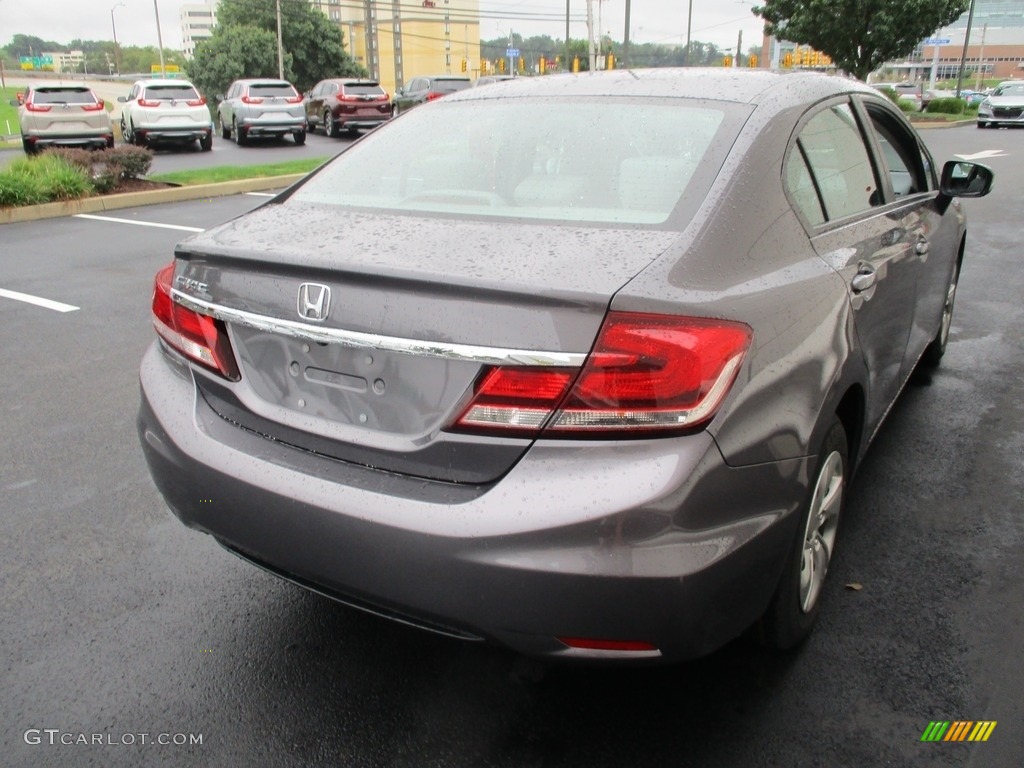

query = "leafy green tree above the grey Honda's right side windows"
[[753, 0, 970, 80]]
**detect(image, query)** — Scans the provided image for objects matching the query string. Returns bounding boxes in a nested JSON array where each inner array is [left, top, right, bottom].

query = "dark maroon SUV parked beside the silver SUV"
[[306, 78, 391, 136]]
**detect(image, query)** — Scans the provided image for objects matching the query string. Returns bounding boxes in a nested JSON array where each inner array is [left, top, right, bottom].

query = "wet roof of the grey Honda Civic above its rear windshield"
[[445, 67, 884, 109]]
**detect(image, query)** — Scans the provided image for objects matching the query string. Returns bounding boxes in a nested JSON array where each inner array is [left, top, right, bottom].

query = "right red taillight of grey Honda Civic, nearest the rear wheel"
[[452, 312, 751, 437]]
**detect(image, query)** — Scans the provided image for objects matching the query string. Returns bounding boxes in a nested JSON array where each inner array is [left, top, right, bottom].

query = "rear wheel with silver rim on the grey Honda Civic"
[[757, 417, 850, 649]]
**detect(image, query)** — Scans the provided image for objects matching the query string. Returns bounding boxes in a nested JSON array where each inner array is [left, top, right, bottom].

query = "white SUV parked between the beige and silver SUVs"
[[118, 78, 213, 152]]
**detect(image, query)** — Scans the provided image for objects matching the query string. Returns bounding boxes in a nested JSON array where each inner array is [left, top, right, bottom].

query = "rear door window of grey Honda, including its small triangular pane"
[[786, 103, 884, 222]]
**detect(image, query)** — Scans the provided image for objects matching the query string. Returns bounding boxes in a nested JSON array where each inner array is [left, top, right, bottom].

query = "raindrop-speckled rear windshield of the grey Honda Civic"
[[292, 98, 749, 224]]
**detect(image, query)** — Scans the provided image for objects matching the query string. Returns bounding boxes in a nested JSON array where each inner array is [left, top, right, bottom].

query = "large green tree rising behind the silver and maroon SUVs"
[[209, 0, 367, 91]]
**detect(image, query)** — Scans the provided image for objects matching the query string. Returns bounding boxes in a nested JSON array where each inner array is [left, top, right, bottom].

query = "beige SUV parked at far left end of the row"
[[10, 81, 114, 155]]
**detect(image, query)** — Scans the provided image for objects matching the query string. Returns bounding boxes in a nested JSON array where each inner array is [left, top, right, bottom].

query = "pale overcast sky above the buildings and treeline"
[[0, 0, 762, 50]]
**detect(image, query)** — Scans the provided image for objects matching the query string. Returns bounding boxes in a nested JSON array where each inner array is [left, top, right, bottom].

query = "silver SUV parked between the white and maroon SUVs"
[[217, 79, 306, 146]]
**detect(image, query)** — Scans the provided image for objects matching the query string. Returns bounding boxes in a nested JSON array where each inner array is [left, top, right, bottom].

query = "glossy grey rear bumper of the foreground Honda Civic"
[[138, 344, 806, 659]]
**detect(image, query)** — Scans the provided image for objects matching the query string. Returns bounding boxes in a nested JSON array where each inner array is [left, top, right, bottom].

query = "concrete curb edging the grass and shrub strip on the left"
[[0, 173, 306, 224]]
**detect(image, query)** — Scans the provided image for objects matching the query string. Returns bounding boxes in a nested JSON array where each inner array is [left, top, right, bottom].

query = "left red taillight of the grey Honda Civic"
[[153, 262, 241, 381]]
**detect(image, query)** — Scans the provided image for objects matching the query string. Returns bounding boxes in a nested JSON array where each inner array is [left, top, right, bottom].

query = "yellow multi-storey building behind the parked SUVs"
[[311, 0, 480, 94]]
